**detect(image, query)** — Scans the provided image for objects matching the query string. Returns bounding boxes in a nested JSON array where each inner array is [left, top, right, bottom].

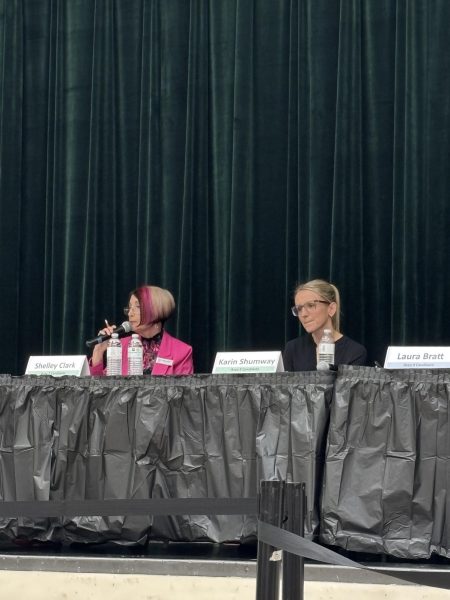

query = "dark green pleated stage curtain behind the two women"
[[0, 0, 450, 374]]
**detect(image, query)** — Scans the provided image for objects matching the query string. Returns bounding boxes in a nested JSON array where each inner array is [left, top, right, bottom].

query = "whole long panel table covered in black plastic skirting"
[[0, 367, 450, 558]]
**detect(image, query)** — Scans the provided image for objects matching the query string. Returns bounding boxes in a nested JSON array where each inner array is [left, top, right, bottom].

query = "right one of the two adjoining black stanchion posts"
[[282, 483, 306, 600]]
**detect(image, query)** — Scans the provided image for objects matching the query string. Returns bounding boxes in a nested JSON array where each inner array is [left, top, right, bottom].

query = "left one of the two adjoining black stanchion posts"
[[256, 481, 284, 600]]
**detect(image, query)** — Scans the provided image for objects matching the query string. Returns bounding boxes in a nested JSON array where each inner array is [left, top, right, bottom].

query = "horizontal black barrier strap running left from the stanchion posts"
[[0, 498, 258, 518]]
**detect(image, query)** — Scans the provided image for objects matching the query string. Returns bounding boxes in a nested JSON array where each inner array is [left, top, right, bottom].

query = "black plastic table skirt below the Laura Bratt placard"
[[320, 367, 450, 559]]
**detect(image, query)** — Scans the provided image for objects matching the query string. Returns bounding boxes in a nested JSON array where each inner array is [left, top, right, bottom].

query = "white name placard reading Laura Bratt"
[[384, 346, 450, 369]]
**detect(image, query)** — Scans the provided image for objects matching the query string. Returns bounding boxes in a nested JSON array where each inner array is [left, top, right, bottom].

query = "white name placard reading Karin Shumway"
[[212, 350, 284, 373]]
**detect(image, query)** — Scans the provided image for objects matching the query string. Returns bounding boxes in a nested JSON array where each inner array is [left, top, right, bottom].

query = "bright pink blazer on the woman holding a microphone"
[[90, 331, 194, 375]]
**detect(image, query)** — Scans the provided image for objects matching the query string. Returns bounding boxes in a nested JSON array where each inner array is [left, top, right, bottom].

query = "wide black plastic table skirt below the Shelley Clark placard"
[[0, 372, 334, 544]]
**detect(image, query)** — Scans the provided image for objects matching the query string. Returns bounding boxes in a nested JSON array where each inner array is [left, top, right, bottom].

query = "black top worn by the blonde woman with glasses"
[[283, 335, 367, 371]]
